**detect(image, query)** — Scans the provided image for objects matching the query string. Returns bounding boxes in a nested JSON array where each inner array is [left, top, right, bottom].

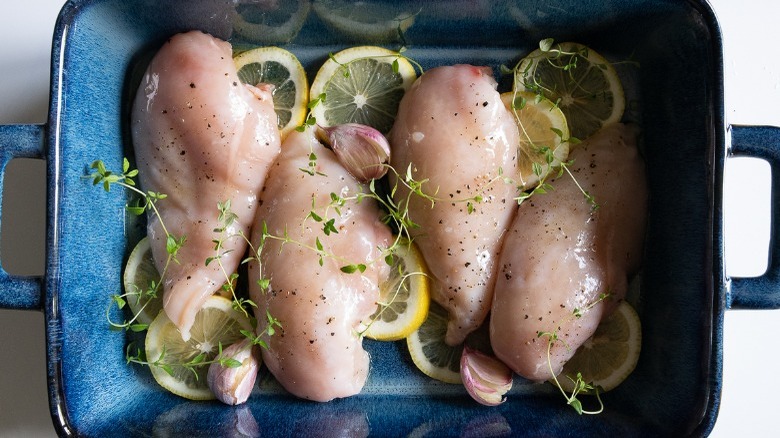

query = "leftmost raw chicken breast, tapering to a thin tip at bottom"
[[132, 31, 280, 340]]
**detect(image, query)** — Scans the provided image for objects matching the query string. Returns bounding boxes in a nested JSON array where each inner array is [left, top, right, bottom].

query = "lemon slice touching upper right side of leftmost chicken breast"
[[233, 47, 309, 140]]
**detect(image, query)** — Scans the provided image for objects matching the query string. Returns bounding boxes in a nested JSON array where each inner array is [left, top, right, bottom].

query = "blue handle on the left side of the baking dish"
[[0, 125, 46, 310]]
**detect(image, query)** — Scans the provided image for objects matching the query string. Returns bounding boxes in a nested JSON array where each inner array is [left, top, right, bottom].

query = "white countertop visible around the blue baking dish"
[[0, 0, 780, 437]]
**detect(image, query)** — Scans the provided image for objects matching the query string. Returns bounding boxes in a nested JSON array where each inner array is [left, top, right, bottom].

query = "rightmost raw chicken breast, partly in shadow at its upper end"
[[490, 124, 647, 381]]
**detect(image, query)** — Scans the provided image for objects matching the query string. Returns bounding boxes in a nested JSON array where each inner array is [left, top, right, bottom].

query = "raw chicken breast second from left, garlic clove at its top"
[[249, 129, 392, 401]]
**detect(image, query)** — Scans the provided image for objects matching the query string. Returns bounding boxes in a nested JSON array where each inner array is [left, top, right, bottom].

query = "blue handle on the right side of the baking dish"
[[726, 125, 780, 309]]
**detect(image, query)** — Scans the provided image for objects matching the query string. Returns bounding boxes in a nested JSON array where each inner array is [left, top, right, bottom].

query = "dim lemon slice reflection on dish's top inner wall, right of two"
[[314, 0, 416, 44]]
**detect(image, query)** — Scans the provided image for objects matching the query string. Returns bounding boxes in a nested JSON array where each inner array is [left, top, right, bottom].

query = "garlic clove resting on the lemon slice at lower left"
[[208, 339, 260, 405]]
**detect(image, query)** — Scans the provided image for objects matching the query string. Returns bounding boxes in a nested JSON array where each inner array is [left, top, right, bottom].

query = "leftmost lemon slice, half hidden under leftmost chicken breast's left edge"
[[122, 237, 163, 324]]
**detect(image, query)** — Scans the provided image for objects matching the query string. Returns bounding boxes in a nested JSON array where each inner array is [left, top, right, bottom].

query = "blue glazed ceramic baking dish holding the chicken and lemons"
[[0, 0, 780, 437]]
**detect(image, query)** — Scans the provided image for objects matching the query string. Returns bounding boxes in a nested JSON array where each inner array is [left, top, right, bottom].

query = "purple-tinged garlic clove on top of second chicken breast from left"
[[315, 123, 390, 183]]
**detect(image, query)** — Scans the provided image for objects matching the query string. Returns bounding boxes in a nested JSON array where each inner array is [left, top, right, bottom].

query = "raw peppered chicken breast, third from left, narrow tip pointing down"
[[390, 65, 519, 345]]
